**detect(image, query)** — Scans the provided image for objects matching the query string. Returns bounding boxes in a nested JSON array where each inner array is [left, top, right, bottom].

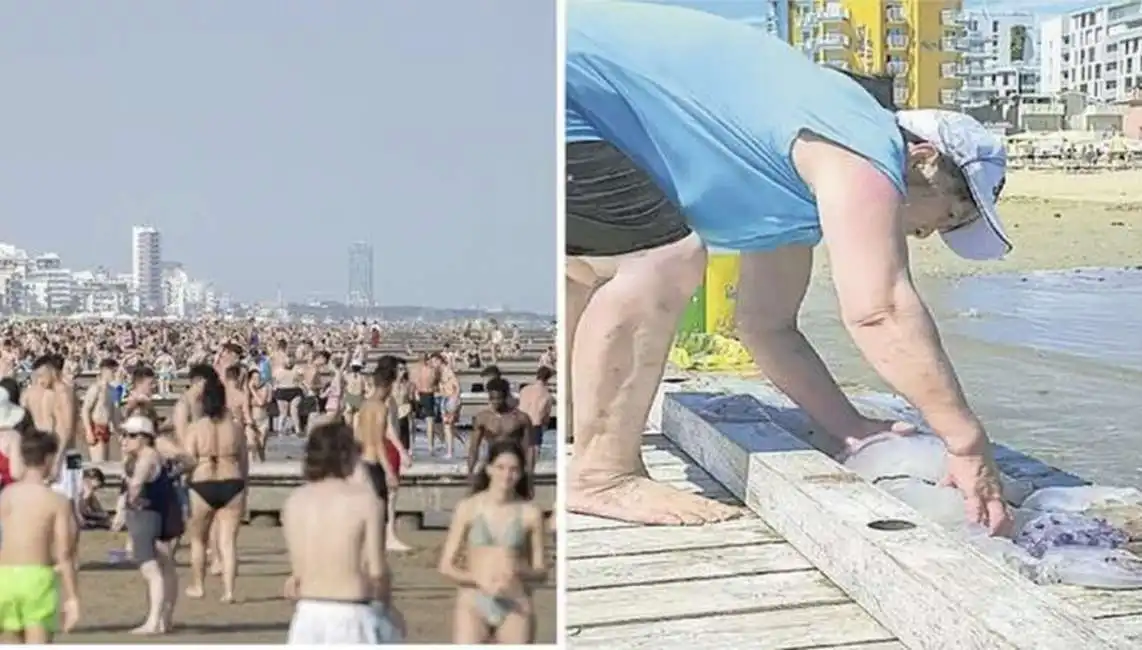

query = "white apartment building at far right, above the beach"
[[1039, 0, 1142, 102]]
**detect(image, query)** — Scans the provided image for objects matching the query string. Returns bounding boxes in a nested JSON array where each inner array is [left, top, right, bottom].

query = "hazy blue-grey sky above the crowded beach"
[[0, 0, 556, 311]]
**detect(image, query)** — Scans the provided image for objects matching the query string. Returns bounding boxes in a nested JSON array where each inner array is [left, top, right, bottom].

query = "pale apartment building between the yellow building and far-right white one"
[[959, 10, 1039, 106]]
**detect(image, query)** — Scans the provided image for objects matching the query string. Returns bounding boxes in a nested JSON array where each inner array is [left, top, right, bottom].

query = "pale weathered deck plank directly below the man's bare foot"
[[565, 517, 785, 560]]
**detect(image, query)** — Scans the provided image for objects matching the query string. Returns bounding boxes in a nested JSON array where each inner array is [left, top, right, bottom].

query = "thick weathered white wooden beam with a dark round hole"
[[662, 393, 1128, 650]]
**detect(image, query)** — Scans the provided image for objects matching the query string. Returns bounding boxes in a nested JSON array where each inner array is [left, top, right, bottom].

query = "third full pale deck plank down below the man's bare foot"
[[566, 571, 849, 627]]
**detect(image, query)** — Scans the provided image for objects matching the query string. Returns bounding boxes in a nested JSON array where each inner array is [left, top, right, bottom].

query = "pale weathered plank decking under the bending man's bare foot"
[[565, 434, 904, 650]]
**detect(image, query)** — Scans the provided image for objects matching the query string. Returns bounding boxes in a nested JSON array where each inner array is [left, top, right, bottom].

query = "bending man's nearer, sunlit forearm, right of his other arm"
[[849, 290, 987, 454]]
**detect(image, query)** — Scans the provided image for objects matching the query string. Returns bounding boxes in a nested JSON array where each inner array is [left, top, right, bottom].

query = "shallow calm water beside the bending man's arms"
[[804, 268, 1142, 487]]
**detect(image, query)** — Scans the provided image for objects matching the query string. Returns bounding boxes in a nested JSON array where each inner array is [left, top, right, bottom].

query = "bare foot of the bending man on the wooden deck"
[[568, 474, 745, 525]]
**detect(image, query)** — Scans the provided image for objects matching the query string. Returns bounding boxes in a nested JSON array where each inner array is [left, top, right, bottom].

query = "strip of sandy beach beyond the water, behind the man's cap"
[[817, 170, 1142, 279]]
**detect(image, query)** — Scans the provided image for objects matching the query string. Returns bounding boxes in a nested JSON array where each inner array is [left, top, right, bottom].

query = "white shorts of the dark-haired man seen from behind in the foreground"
[[286, 600, 403, 645]]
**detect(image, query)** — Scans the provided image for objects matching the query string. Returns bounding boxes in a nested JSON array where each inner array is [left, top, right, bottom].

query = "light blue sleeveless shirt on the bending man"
[[565, 0, 906, 250]]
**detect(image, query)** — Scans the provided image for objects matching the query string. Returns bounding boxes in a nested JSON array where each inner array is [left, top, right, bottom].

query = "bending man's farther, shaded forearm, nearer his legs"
[[740, 328, 863, 439]]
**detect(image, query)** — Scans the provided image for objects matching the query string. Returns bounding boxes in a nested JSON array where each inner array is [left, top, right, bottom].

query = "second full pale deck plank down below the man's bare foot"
[[564, 539, 813, 599]]
